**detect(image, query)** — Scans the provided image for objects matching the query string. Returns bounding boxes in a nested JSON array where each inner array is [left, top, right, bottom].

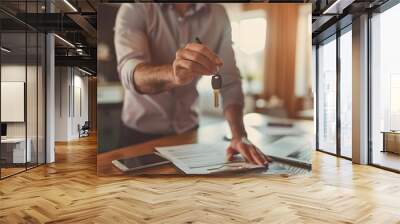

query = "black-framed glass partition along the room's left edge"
[[0, 1, 46, 179]]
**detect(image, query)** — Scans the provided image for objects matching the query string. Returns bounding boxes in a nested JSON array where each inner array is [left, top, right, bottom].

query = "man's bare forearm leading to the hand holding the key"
[[133, 63, 175, 94]]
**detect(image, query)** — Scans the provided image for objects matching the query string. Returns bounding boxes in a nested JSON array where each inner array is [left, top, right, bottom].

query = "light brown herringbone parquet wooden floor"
[[0, 134, 400, 224]]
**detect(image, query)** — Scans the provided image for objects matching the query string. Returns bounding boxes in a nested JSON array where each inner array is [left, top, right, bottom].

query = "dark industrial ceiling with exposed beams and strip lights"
[[0, 0, 394, 71]]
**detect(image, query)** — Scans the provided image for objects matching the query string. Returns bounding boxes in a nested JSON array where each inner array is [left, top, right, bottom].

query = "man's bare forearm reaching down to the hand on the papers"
[[224, 104, 247, 138]]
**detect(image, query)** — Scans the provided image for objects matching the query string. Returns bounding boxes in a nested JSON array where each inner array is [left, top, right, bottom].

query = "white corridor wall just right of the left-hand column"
[[55, 67, 89, 141]]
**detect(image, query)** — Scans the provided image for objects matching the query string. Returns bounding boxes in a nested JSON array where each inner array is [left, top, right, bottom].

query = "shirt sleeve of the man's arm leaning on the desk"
[[217, 9, 244, 108]]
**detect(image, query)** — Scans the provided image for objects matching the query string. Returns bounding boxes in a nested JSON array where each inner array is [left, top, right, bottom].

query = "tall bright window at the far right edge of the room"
[[370, 1, 400, 170]]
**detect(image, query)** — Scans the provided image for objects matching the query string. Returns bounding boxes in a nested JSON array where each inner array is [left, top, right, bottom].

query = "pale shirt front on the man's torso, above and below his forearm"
[[119, 4, 225, 134]]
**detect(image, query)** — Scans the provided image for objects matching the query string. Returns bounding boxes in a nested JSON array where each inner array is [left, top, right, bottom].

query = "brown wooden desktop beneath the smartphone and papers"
[[97, 115, 313, 176]]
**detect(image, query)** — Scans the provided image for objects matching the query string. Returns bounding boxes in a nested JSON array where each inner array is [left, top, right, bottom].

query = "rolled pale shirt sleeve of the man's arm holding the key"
[[114, 3, 151, 94]]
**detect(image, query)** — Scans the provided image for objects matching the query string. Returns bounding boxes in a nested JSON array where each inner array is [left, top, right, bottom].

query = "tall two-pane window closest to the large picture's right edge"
[[316, 25, 353, 159]]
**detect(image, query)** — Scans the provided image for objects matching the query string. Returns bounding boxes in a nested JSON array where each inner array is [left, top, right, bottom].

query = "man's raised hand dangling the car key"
[[172, 43, 223, 85]]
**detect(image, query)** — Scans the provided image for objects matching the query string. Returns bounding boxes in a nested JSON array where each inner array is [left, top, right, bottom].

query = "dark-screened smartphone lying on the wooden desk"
[[112, 154, 170, 172]]
